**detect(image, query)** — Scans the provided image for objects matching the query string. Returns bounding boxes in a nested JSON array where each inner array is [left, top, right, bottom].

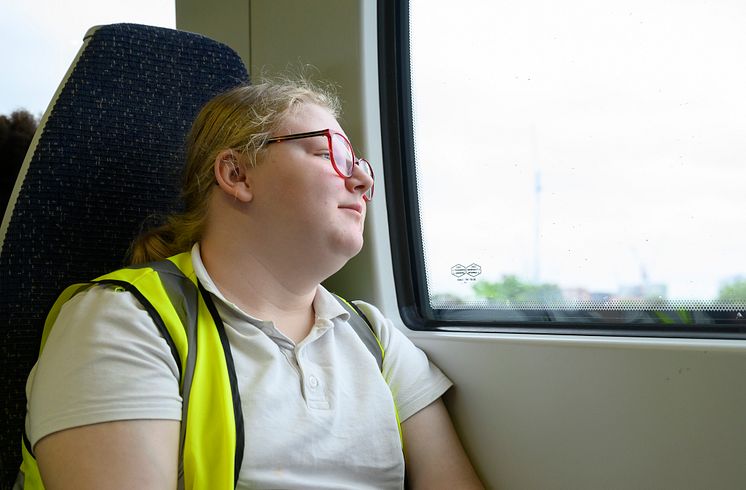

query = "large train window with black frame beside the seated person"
[[378, 0, 746, 337]]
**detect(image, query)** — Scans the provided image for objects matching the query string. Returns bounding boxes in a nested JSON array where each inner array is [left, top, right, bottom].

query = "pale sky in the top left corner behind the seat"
[[0, 0, 176, 116]]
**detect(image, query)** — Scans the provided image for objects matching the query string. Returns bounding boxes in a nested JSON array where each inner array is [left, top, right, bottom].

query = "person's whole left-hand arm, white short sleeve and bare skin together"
[[28, 287, 181, 490]]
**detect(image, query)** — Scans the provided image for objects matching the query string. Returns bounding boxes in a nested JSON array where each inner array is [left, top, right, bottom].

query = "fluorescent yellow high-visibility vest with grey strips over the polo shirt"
[[19, 252, 386, 490]]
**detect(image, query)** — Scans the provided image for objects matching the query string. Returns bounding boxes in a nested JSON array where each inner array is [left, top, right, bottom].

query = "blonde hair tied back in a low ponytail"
[[129, 79, 341, 264]]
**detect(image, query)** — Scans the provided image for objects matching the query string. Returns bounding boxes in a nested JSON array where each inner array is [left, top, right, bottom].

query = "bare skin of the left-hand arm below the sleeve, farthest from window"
[[34, 420, 180, 490]]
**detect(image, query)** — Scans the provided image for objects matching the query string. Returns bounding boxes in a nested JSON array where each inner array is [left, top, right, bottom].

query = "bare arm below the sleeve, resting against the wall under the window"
[[402, 398, 484, 489]]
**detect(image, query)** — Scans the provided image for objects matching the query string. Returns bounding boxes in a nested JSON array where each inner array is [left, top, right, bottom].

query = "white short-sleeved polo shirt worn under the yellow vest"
[[26, 246, 451, 489]]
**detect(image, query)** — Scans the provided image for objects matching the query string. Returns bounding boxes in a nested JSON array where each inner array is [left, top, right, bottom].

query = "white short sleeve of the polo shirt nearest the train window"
[[355, 301, 453, 422]]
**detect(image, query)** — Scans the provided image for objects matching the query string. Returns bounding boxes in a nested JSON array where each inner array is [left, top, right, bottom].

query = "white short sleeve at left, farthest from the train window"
[[26, 286, 181, 447]]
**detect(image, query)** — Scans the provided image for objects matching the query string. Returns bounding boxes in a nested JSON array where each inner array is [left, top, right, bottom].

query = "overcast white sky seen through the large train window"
[[411, 0, 746, 301]]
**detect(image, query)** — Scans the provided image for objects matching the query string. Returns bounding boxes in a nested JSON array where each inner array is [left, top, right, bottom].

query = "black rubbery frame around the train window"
[[377, 0, 746, 339]]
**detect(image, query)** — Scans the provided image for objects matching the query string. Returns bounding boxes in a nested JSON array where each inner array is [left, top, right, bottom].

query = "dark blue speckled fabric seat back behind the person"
[[0, 24, 248, 488]]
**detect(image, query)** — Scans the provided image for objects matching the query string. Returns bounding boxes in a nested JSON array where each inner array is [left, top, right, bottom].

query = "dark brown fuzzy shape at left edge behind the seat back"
[[0, 109, 38, 217]]
